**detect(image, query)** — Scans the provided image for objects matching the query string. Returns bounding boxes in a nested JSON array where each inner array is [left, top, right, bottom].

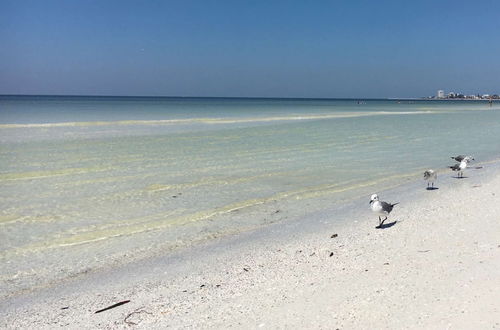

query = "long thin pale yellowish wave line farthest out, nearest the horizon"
[[0, 110, 444, 128]]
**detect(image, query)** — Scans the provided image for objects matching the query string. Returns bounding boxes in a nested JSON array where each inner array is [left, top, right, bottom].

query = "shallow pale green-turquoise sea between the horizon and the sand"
[[0, 96, 500, 294]]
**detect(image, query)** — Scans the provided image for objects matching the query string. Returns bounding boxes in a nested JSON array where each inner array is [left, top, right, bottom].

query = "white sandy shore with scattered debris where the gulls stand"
[[0, 162, 500, 329]]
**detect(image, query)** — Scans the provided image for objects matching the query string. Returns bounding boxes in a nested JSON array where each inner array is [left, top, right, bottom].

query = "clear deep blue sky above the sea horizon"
[[0, 0, 500, 98]]
